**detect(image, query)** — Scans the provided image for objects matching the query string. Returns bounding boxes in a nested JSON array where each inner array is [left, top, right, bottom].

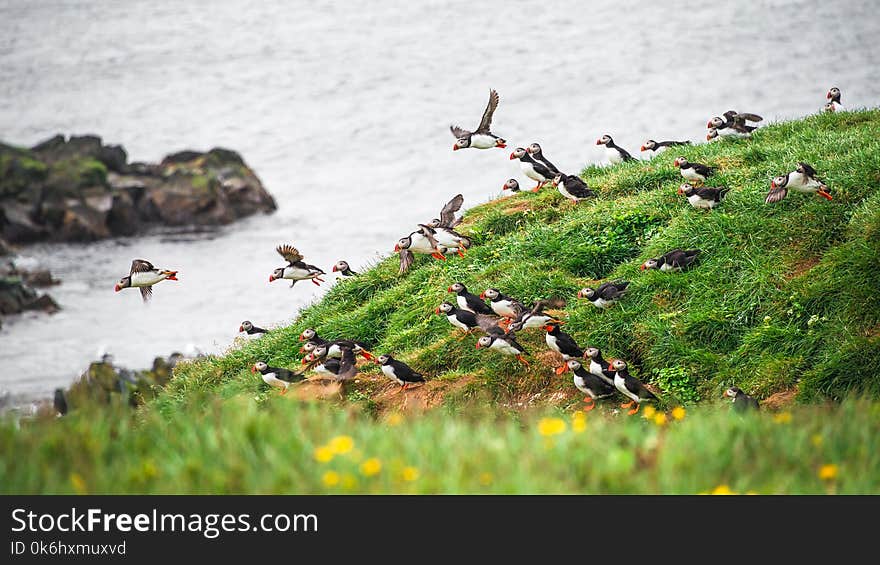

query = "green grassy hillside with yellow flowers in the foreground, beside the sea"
[[0, 110, 880, 493]]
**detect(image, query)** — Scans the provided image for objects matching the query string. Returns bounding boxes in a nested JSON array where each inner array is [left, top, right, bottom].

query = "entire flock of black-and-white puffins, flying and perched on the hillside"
[[116, 87, 841, 415]]
